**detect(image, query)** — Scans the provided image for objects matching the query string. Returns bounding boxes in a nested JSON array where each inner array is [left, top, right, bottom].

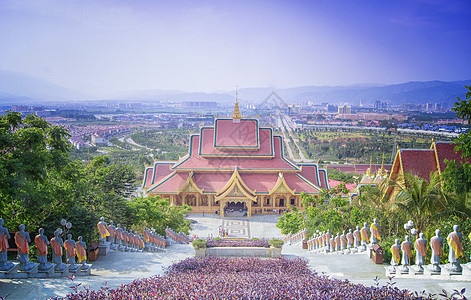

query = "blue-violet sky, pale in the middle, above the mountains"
[[0, 0, 471, 95]]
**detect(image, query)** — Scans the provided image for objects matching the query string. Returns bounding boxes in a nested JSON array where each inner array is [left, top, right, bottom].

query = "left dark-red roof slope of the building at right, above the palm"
[[400, 149, 438, 180]]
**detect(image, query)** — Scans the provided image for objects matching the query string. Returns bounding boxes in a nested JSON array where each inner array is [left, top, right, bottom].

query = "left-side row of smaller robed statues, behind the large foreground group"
[[97, 217, 166, 252]]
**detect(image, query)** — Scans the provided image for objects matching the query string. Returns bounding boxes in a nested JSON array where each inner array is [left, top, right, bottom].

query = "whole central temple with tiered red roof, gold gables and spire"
[[142, 100, 329, 217]]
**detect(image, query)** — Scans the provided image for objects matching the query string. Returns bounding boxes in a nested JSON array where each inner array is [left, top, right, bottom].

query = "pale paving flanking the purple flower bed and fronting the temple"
[[0, 214, 471, 300]]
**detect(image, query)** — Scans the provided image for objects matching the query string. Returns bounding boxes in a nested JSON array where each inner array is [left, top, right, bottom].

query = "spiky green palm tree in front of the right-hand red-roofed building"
[[394, 172, 447, 232]]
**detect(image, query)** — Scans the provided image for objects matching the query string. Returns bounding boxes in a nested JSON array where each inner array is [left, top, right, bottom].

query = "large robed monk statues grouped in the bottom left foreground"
[[0, 218, 90, 272]]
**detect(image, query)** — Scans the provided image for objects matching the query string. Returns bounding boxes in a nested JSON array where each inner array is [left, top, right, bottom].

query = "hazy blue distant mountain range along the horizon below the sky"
[[0, 71, 471, 106]]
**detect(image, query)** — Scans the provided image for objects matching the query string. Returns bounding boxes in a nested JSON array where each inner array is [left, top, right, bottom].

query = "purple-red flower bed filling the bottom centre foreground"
[[60, 257, 431, 299]]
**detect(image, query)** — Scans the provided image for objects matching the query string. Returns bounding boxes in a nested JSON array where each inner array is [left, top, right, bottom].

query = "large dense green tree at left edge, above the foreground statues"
[[0, 111, 72, 230]]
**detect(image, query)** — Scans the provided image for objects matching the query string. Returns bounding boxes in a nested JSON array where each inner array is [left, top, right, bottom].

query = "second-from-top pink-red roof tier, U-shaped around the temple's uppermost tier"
[[199, 127, 273, 157]]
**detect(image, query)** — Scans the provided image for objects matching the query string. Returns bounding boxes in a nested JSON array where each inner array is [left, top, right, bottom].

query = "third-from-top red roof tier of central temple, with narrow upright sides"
[[172, 135, 299, 171]]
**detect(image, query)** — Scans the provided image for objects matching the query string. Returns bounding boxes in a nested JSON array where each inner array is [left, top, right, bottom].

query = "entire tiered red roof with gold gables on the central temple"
[[143, 107, 328, 198]]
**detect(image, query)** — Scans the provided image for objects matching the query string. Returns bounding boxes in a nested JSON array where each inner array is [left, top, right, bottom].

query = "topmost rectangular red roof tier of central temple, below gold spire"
[[214, 119, 259, 148]]
